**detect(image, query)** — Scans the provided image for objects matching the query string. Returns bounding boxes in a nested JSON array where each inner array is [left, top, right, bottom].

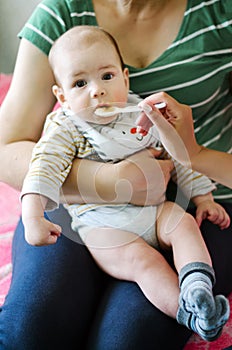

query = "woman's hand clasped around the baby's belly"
[[111, 149, 173, 205]]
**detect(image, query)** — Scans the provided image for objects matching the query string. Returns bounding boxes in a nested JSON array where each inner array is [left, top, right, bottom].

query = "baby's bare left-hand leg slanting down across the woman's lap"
[[85, 228, 180, 318]]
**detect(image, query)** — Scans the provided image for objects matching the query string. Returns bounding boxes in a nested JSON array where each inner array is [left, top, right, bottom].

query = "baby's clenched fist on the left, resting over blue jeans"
[[23, 216, 61, 246]]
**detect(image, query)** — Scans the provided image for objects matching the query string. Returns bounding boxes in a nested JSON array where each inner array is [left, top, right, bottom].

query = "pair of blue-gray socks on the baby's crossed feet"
[[176, 262, 230, 341]]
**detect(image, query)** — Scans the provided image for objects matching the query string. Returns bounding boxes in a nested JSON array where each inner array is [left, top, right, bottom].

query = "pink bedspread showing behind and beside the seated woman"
[[0, 74, 232, 350]]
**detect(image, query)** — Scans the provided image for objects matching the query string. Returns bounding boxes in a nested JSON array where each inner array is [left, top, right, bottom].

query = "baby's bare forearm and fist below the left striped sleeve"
[[22, 193, 61, 246]]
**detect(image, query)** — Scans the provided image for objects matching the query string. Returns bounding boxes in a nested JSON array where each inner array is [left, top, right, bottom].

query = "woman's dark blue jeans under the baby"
[[0, 206, 232, 350]]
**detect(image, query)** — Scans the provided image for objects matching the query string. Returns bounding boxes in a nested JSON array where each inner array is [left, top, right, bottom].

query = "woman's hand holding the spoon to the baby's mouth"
[[137, 92, 201, 166]]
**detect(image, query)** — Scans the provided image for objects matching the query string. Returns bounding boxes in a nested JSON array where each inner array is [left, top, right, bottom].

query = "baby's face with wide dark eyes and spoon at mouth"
[[57, 41, 129, 124]]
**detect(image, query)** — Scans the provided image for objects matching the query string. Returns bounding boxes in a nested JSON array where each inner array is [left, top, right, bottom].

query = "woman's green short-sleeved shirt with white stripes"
[[19, 0, 232, 201]]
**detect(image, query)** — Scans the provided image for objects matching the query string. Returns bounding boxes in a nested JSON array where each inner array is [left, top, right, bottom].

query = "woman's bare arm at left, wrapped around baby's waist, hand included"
[[0, 39, 172, 204]]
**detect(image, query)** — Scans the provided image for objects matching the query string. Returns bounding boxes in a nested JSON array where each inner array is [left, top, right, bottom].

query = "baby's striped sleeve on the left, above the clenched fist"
[[21, 113, 76, 210]]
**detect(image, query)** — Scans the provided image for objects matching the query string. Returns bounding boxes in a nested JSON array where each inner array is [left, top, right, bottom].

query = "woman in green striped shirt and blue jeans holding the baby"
[[0, 0, 232, 350]]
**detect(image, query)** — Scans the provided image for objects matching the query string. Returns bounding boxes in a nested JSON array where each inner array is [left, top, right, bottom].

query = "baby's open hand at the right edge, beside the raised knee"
[[196, 200, 230, 230]]
